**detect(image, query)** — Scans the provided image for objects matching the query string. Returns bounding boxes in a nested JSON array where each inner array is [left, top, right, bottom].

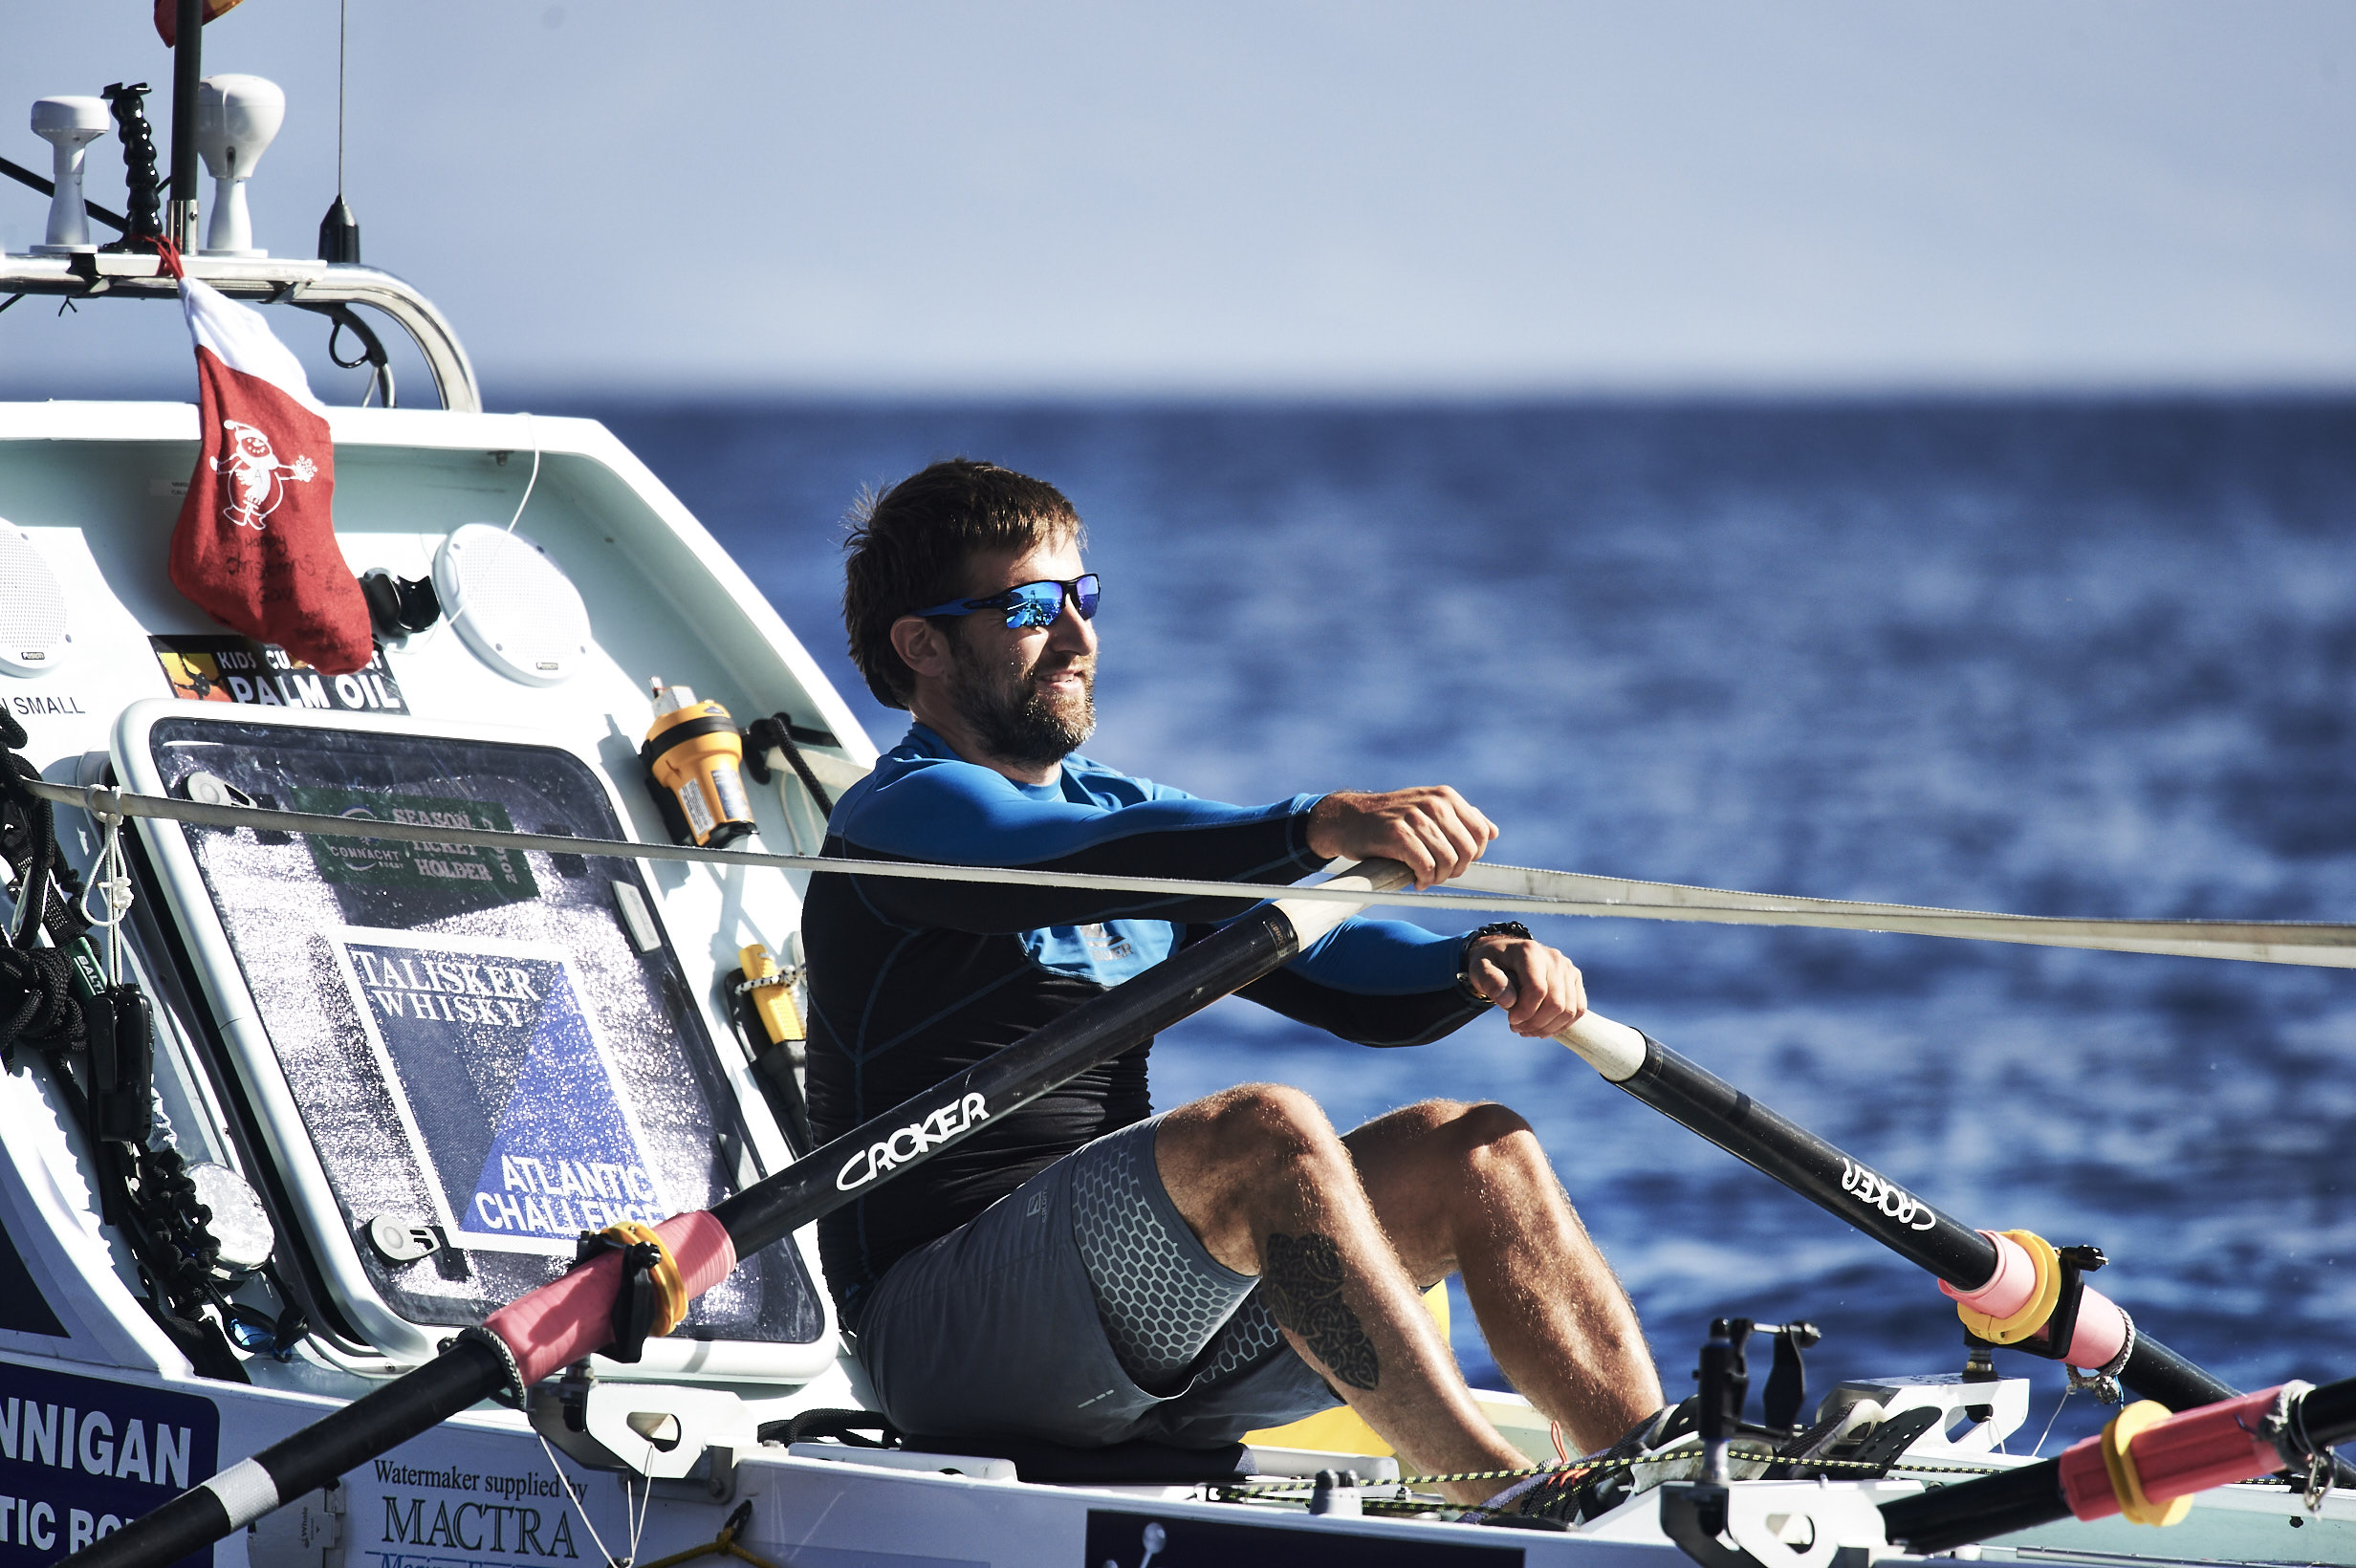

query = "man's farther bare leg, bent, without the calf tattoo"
[[1342, 1100, 1661, 1452]]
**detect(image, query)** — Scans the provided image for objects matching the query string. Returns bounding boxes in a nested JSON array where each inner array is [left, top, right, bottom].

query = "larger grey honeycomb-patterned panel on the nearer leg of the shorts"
[[1072, 1123, 1258, 1394]]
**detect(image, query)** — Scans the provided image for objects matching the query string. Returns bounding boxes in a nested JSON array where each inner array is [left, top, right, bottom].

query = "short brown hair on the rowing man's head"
[[843, 457, 1086, 708]]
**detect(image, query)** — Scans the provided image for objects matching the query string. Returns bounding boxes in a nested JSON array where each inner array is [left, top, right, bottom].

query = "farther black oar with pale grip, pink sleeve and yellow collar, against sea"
[[1555, 1013, 2356, 1481]]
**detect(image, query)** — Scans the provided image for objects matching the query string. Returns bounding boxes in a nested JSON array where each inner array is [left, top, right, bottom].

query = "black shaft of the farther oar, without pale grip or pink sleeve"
[[1619, 1035, 2238, 1410]]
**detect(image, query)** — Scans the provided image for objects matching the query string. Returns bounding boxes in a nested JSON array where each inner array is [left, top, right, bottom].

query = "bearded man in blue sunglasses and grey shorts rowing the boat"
[[803, 459, 1661, 1502]]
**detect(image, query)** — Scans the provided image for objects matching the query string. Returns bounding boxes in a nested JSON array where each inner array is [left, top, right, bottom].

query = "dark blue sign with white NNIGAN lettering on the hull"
[[0, 1361, 222, 1568]]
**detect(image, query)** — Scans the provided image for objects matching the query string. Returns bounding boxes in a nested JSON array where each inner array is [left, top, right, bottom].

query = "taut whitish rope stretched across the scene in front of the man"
[[24, 779, 2356, 970]]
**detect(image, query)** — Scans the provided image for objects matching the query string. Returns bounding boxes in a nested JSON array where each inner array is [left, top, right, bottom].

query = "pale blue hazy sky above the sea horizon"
[[0, 0, 2356, 398]]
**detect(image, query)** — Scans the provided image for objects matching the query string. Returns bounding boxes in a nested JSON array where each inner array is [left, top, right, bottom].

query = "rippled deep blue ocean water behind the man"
[[582, 401, 2356, 1434]]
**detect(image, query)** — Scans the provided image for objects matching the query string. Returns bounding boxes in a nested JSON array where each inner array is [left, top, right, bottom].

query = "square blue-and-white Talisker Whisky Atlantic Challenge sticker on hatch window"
[[330, 926, 671, 1252]]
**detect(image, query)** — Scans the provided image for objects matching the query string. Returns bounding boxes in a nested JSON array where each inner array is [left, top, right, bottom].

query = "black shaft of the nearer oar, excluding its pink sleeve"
[[66, 861, 1375, 1568]]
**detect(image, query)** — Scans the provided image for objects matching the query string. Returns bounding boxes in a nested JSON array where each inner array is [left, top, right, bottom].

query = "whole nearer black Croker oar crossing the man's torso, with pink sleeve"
[[64, 860, 1411, 1568]]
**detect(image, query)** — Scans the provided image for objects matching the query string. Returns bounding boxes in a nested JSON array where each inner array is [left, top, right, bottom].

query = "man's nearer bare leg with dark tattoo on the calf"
[[1154, 1083, 1545, 1502]]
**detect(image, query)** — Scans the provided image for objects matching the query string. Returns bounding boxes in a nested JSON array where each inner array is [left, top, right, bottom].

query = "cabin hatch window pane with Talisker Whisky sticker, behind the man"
[[148, 716, 824, 1344]]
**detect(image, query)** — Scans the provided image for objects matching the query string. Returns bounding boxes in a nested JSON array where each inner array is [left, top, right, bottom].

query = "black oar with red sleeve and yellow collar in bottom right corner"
[[1883, 1378, 2356, 1557]]
